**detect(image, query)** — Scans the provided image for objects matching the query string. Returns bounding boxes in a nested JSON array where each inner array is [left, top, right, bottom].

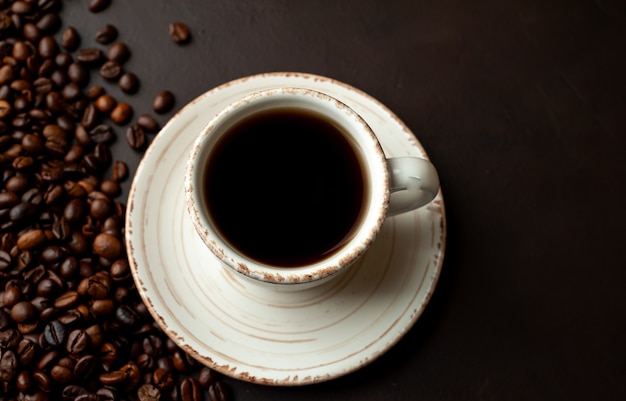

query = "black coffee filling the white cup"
[[205, 108, 367, 267]]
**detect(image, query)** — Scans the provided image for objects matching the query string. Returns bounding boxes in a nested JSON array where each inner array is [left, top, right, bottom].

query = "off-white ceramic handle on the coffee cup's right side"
[[387, 157, 439, 216]]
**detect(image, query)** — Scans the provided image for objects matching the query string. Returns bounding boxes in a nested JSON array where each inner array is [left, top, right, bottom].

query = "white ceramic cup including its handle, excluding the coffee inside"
[[184, 88, 439, 288]]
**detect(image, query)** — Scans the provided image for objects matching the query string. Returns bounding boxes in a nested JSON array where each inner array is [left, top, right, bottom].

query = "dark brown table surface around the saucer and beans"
[[62, 0, 626, 401]]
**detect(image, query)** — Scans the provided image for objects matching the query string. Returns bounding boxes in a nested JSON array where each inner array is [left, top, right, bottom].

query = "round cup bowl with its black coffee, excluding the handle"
[[185, 88, 389, 287]]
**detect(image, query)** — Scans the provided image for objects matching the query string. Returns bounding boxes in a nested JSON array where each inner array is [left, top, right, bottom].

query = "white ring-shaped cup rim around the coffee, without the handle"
[[184, 87, 389, 287]]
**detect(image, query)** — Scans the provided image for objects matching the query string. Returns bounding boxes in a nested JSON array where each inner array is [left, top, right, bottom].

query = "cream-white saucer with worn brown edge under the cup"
[[126, 73, 446, 385]]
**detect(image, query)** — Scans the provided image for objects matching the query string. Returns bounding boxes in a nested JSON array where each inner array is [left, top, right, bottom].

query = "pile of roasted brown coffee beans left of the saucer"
[[0, 0, 230, 401]]
